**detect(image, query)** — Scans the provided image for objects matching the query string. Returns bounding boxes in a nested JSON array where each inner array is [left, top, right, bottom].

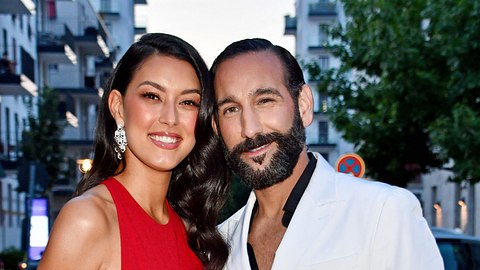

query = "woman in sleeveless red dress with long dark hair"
[[38, 34, 229, 270]]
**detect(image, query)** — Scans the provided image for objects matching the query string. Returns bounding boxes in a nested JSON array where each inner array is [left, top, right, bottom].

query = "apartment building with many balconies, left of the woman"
[[0, 0, 146, 253]]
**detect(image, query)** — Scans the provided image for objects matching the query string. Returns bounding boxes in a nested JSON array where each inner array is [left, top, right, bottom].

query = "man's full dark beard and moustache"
[[222, 110, 305, 190]]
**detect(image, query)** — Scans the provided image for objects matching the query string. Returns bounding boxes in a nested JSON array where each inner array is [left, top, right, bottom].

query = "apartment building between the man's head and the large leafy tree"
[[285, 0, 353, 166]]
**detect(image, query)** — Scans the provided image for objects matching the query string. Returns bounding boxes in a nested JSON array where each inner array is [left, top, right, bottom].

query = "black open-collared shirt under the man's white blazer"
[[247, 153, 317, 270]]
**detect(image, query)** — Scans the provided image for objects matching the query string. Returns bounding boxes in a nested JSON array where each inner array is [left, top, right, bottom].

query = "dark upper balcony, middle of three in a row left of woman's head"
[[38, 24, 77, 65]]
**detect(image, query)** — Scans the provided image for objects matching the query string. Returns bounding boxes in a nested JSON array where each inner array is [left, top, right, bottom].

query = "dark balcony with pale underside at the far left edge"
[[0, 48, 38, 96]]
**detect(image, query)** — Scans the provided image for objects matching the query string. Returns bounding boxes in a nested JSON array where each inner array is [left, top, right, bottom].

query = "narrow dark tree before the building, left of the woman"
[[22, 87, 64, 192]]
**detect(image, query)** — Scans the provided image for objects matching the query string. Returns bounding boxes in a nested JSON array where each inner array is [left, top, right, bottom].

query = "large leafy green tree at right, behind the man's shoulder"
[[312, 0, 480, 186]]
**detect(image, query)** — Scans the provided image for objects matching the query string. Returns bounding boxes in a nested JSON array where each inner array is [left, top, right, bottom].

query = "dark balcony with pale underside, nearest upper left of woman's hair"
[[75, 26, 110, 57]]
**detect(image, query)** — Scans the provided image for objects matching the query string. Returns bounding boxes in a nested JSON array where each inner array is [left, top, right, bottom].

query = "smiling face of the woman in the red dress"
[[112, 55, 201, 171]]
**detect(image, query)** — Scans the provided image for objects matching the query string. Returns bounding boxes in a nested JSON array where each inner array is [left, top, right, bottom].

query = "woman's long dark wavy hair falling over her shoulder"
[[75, 33, 230, 270]]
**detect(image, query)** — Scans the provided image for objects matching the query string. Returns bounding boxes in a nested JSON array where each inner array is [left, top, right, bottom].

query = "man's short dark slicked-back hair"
[[208, 38, 305, 125]]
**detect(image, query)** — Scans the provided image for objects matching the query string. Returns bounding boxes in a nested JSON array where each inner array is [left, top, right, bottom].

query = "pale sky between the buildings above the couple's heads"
[[135, 0, 295, 67]]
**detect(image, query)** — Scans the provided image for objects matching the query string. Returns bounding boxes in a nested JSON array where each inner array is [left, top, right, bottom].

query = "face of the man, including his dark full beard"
[[214, 52, 305, 190]]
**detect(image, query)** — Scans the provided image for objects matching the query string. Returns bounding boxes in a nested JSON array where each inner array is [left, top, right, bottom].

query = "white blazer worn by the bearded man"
[[219, 153, 444, 270]]
